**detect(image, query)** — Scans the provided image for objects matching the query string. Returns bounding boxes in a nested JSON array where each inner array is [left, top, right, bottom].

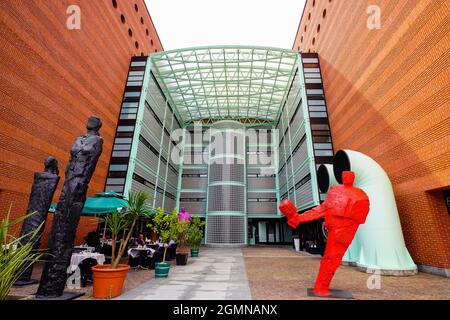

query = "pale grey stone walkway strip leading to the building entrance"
[[116, 248, 252, 300]]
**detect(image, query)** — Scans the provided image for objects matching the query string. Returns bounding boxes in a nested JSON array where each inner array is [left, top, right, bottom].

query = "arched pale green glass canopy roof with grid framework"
[[150, 46, 298, 123]]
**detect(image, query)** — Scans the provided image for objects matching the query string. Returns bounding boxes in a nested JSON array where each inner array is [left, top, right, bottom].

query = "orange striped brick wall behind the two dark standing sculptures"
[[0, 0, 162, 246]]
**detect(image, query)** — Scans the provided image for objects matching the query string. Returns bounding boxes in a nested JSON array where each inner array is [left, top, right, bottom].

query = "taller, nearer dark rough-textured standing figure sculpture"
[[36, 117, 103, 299]]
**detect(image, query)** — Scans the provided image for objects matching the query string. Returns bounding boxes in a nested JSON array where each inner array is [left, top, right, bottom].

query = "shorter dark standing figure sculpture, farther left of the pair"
[[14, 157, 59, 286]]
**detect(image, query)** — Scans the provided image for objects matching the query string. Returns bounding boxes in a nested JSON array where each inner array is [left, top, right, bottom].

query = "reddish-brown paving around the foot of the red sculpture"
[[242, 246, 450, 300]]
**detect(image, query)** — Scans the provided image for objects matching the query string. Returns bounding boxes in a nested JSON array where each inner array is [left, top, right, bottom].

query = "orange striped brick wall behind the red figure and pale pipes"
[[293, 0, 450, 268]]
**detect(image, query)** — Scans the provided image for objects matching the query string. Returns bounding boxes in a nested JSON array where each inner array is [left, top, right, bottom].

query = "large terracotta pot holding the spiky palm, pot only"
[[92, 264, 130, 299]]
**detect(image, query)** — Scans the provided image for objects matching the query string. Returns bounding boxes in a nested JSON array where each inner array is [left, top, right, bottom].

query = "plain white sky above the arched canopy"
[[145, 0, 305, 50]]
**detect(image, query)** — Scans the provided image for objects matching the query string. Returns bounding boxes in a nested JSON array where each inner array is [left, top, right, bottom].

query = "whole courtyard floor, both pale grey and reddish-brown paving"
[[11, 246, 450, 300]]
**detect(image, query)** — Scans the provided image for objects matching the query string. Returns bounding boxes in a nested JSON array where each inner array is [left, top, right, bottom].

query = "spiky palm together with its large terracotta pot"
[[92, 192, 153, 299]]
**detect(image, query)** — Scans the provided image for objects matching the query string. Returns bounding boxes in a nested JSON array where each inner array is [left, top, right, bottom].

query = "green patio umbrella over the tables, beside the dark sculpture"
[[49, 192, 129, 216]]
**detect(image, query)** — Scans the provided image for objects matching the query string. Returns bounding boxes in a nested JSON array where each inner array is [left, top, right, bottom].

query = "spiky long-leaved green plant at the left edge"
[[0, 207, 43, 300]]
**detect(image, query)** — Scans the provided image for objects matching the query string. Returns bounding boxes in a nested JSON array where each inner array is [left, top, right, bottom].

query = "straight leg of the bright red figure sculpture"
[[313, 225, 358, 295]]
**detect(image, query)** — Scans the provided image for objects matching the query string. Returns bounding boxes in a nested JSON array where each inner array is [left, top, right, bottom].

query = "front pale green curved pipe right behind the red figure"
[[333, 150, 417, 275]]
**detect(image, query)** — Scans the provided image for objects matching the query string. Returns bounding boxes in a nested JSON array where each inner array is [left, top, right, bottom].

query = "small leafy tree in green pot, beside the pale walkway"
[[147, 208, 178, 278]]
